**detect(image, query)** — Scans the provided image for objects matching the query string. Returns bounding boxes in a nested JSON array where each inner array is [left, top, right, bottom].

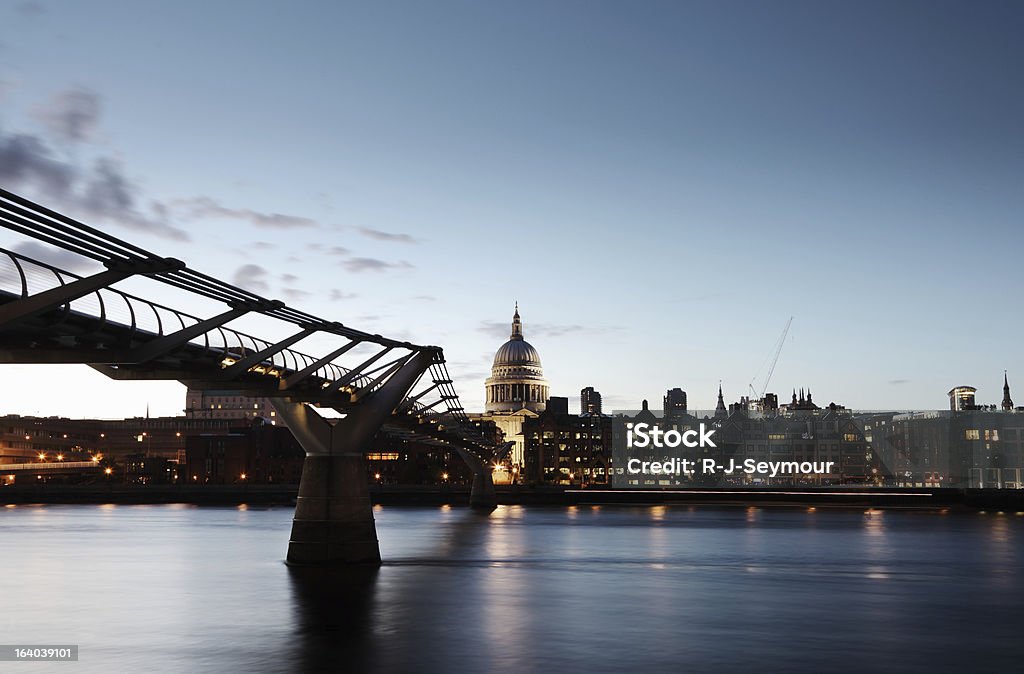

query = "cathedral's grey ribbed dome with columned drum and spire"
[[485, 304, 548, 412]]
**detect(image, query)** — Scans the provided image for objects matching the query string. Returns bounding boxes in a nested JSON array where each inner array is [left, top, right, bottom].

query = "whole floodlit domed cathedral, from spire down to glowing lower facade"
[[470, 303, 548, 473]]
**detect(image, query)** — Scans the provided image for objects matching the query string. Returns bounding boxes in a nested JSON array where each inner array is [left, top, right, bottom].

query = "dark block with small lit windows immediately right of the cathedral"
[[523, 397, 611, 487]]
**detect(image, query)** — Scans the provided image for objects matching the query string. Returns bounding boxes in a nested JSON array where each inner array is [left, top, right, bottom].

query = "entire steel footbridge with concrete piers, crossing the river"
[[0, 188, 511, 564]]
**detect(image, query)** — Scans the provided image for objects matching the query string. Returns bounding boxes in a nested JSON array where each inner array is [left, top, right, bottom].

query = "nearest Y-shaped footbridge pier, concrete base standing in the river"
[[271, 352, 432, 565]]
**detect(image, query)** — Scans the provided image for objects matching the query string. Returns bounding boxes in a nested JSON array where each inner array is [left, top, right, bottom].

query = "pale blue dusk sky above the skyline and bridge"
[[0, 0, 1024, 417]]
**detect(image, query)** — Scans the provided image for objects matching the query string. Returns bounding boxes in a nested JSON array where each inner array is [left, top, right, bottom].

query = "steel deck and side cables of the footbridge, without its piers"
[[0, 188, 496, 458]]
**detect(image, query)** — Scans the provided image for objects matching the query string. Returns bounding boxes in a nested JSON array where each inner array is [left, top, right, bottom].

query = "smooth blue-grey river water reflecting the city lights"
[[0, 505, 1024, 672]]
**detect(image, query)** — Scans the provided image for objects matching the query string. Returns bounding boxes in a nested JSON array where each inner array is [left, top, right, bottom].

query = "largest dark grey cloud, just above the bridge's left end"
[[0, 131, 188, 241]]
